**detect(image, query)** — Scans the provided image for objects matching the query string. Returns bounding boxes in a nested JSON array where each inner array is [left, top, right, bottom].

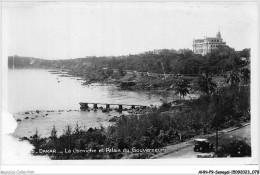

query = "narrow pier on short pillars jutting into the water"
[[79, 102, 147, 110]]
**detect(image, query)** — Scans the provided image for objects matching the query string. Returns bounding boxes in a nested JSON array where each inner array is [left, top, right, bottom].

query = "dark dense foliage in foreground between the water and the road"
[[23, 82, 250, 159]]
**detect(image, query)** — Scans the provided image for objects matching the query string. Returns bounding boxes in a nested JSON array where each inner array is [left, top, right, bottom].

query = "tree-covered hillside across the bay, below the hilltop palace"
[[8, 46, 250, 75]]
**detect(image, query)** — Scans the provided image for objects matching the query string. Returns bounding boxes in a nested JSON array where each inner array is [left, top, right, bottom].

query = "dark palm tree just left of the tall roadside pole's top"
[[198, 74, 217, 96]]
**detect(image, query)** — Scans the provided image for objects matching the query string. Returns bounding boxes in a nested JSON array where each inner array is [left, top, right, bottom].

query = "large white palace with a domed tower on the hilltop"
[[192, 31, 226, 55]]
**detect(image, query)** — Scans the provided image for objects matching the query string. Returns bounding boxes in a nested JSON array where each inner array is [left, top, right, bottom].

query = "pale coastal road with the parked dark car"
[[153, 123, 251, 159]]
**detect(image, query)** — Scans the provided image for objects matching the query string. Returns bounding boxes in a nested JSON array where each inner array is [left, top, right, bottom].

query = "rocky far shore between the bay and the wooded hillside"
[[49, 70, 201, 93]]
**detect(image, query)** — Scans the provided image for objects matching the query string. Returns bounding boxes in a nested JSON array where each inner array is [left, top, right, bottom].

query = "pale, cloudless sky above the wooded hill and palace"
[[2, 2, 257, 59]]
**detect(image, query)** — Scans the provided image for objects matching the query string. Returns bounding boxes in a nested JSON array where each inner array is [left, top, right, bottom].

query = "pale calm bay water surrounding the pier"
[[8, 69, 178, 137]]
